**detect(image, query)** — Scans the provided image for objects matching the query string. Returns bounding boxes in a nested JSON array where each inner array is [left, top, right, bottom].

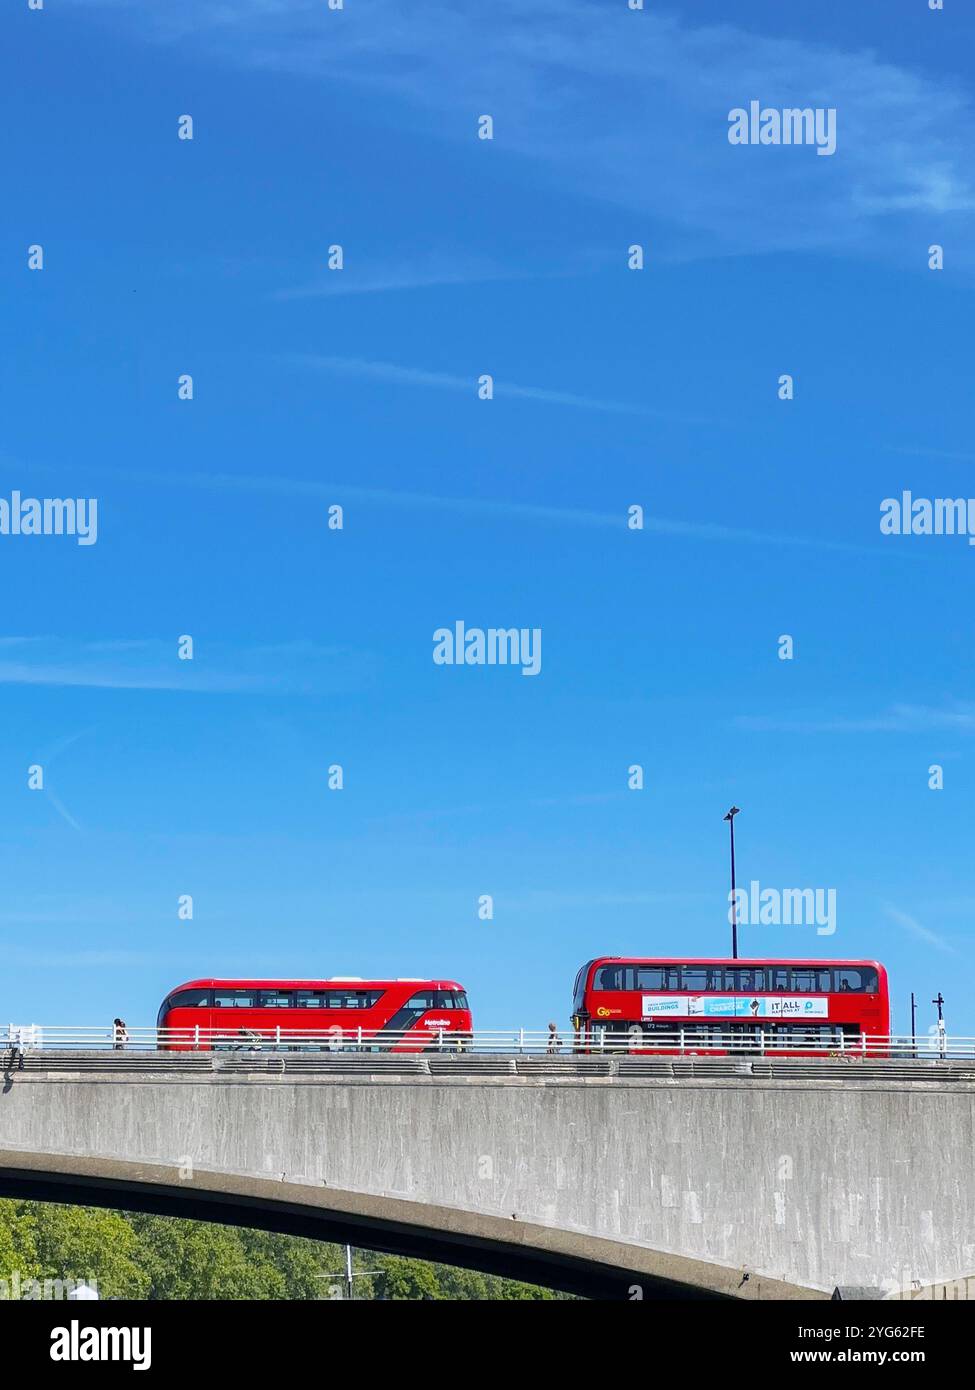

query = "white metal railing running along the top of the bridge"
[[0, 1023, 975, 1062]]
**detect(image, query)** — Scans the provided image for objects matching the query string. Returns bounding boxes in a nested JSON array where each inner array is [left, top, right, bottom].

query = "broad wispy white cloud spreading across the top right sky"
[[74, 0, 975, 265]]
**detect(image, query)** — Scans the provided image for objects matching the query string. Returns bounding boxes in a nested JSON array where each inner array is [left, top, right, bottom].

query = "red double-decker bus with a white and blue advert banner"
[[572, 956, 890, 1056]]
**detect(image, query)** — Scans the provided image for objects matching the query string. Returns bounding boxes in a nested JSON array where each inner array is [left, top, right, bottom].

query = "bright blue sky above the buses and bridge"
[[0, 0, 975, 1034]]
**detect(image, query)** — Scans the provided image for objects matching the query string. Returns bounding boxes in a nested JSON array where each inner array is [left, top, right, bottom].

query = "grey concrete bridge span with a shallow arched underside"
[[0, 1052, 975, 1298]]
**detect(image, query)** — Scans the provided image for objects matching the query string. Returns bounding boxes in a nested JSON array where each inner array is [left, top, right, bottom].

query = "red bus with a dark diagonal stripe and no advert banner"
[[156, 976, 472, 1052]]
